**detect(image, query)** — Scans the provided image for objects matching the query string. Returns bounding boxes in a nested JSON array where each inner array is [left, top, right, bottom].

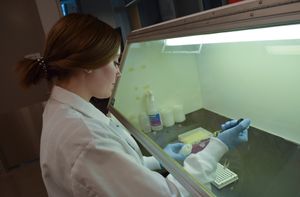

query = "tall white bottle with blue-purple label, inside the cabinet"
[[146, 91, 163, 131]]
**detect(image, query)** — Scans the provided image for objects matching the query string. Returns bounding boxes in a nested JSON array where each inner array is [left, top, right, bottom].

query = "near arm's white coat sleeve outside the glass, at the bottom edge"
[[71, 135, 179, 197]]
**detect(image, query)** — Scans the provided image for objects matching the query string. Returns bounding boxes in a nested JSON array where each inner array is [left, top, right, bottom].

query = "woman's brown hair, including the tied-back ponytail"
[[16, 14, 121, 87]]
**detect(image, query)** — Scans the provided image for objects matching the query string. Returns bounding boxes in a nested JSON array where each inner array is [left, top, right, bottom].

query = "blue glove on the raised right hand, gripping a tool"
[[218, 119, 250, 150]]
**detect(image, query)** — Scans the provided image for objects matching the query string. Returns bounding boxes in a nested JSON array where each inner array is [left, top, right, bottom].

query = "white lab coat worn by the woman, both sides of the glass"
[[40, 86, 227, 197]]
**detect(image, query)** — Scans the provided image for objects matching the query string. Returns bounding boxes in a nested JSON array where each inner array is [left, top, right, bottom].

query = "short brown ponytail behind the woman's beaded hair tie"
[[16, 58, 47, 88]]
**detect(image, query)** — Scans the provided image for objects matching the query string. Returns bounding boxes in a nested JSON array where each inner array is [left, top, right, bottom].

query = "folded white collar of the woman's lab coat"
[[50, 86, 110, 125]]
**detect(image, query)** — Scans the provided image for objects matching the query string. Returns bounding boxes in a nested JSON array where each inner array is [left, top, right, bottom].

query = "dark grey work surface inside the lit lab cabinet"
[[148, 109, 300, 197]]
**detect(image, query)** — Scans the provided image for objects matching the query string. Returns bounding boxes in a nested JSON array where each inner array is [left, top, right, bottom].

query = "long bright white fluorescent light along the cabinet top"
[[165, 24, 300, 46]]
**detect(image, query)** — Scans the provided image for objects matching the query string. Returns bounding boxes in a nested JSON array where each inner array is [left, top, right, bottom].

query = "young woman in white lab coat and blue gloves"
[[17, 14, 250, 197]]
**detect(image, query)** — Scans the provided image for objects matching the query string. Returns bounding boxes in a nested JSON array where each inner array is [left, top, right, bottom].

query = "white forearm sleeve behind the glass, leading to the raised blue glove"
[[167, 137, 228, 196]]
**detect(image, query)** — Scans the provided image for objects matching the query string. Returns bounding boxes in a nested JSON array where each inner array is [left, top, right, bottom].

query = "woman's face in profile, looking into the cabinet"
[[88, 53, 121, 98]]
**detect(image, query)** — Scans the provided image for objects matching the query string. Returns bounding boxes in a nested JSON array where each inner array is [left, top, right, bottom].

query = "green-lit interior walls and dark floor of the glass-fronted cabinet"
[[114, 25, 300, 197]]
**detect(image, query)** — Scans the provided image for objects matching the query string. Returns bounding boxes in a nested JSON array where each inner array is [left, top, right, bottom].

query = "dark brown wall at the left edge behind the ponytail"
[[0, 0, 59, 114]]
